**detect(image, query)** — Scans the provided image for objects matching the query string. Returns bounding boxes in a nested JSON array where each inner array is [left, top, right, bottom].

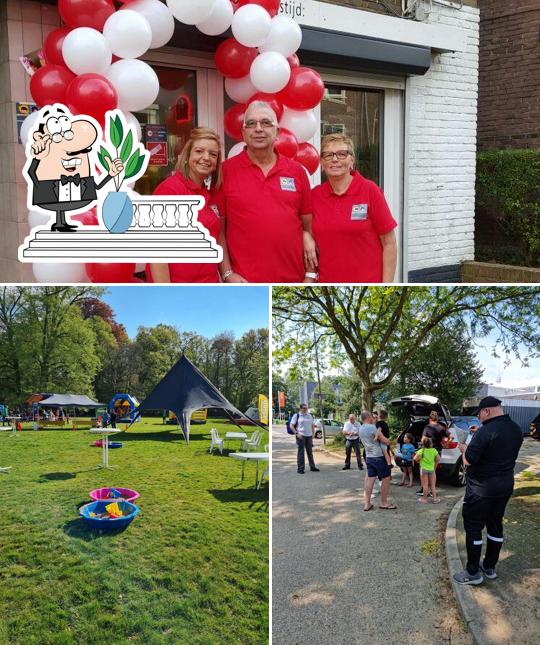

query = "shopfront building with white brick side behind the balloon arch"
[[0, 0, 479, 282]]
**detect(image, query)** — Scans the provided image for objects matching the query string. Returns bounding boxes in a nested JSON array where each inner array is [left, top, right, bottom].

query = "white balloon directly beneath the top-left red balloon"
[[62, 27, 112, 76]]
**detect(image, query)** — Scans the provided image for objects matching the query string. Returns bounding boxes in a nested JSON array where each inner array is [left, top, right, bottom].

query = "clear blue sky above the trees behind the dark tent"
[[102, 285, 268, 338]]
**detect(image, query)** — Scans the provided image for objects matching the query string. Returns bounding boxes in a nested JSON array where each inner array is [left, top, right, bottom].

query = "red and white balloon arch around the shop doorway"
[[21, 0, 324, 281]]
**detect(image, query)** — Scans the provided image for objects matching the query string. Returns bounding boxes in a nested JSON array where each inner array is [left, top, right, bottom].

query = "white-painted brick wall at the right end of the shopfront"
[[404, 5, 480, 272]]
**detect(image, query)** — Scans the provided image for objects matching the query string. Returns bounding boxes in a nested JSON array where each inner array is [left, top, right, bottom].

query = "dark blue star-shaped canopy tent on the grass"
[[137, 356, 262, 443]]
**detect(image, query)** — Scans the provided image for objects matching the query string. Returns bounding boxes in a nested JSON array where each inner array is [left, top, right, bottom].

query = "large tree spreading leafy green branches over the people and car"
[[273, 286, 540, 408]]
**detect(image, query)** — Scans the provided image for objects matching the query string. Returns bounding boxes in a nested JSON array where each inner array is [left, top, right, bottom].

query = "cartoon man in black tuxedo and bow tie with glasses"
[[27, 104, 124, 233]]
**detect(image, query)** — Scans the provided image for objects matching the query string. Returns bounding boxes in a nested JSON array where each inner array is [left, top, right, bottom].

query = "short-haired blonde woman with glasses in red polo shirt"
[[312, 134, 397, 282]]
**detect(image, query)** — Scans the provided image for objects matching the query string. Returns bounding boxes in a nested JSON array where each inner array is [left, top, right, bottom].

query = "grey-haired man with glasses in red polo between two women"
[[221, 101, 317, 282]]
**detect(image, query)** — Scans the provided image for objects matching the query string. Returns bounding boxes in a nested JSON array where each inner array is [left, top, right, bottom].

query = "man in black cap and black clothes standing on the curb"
[[454, 396, 523, 585]]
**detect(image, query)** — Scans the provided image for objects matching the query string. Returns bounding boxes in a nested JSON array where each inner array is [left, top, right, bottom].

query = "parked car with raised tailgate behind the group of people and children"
[[390, 394, 469, 486]]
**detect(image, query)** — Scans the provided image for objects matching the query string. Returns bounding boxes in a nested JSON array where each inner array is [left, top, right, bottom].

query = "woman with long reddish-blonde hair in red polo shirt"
[[146, 128, 245, 282]]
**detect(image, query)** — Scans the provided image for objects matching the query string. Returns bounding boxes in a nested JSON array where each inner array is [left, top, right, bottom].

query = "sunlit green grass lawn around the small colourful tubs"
[[0, 418, 268, 645]]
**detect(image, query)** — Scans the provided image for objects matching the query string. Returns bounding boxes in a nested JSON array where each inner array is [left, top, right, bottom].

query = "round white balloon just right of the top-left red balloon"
[[103, 9, 152, 58]]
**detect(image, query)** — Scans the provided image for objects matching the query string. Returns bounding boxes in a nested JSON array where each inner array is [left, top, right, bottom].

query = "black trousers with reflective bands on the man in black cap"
[[463, 494, 510, 575]]
